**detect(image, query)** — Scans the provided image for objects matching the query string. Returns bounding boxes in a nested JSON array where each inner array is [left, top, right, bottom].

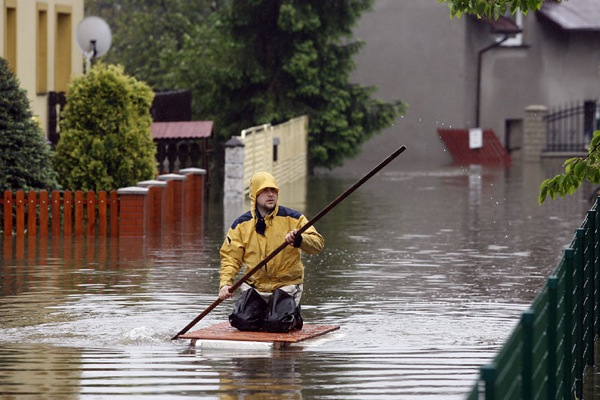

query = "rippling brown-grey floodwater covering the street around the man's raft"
[[0, 157, 590, 400]]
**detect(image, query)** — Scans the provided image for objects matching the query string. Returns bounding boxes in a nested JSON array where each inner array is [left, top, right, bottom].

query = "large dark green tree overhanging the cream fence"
[[180, 0, 405, 168]]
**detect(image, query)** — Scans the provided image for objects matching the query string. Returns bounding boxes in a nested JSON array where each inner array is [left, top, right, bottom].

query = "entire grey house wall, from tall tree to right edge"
[[344, 0, 600, 169]]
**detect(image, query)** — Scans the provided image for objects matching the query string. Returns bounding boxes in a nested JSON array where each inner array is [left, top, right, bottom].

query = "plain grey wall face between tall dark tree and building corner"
[[344, 0, 464, 170]]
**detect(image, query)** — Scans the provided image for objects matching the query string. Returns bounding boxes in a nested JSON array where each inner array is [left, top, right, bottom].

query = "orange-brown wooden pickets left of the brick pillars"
[[0, 190, 119, 237]]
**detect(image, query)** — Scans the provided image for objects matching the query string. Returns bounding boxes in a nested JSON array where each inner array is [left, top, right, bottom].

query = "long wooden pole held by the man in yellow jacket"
[[171, 146, 406, 340]]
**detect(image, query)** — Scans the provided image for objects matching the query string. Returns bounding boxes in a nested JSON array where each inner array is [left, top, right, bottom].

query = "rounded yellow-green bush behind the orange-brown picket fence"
[[55, 63, 157, 191]]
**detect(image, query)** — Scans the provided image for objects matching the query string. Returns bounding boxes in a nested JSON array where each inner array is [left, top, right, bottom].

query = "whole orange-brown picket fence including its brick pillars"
[[0, 168, 206, 238]]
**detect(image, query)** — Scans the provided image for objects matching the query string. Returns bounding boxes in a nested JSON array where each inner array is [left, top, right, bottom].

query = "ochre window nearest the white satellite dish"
[[54, 5, 72, 92]]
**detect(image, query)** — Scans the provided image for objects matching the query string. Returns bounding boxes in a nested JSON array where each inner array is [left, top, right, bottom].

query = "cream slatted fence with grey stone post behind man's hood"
[[224, 116, 308, 201]]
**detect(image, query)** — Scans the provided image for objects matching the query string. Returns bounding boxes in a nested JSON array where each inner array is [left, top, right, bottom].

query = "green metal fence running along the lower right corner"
[[467, 198, 600, 400]]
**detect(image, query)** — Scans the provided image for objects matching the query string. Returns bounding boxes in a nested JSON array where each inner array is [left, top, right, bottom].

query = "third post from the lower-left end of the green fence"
[[546, 276, 560, 399]]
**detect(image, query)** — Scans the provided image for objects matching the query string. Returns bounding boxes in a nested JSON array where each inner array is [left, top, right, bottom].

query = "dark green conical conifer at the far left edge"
[[0, 57, 58, 191]]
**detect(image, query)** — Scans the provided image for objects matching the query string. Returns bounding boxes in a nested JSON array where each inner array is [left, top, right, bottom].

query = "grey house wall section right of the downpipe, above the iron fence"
[[481, 13, 600, 150]]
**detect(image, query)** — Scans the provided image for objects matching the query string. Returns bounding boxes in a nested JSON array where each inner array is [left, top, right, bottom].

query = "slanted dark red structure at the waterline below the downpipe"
[[437, 129, 511, 165]]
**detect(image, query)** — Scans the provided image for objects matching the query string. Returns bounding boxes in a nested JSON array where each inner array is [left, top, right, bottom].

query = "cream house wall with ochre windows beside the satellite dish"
[[0, 0, 84, 136]]
